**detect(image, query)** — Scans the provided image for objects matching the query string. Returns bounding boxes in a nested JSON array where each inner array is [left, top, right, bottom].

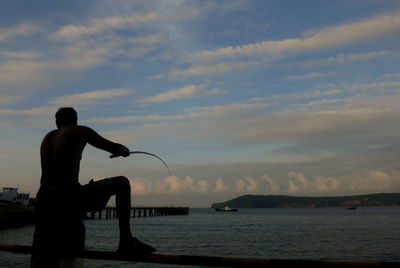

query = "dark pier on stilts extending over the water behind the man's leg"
[[87, 207, 189, 219]]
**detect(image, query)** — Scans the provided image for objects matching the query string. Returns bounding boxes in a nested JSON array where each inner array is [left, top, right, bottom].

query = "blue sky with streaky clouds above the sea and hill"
[[0, 0, 400, 207]]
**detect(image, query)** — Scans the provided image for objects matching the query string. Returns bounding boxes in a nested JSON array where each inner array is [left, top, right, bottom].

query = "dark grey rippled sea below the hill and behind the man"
[[0, 207, 400, 268]]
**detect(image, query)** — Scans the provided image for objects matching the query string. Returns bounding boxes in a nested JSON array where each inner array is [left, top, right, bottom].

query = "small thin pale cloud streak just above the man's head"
[[51, 88, 130, 106]]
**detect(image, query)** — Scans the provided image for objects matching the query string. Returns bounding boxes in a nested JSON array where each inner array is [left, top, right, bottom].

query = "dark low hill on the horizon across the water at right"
[[211, 193, 400, 208]]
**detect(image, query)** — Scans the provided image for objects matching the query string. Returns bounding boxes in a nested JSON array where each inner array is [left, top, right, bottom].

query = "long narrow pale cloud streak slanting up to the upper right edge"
[[190, 13, 400, 60]]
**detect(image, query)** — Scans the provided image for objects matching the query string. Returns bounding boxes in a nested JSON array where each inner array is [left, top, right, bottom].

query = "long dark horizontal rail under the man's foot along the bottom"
[[0, 244, 400, 268]]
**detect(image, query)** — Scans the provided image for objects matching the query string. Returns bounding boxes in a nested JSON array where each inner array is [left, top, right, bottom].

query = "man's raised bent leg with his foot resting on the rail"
[[82, 176, 155, 253]]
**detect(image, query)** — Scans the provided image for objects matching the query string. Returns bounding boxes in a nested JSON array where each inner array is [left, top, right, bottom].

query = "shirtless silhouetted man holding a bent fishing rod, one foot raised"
[[33, 107, 155, 266]]
